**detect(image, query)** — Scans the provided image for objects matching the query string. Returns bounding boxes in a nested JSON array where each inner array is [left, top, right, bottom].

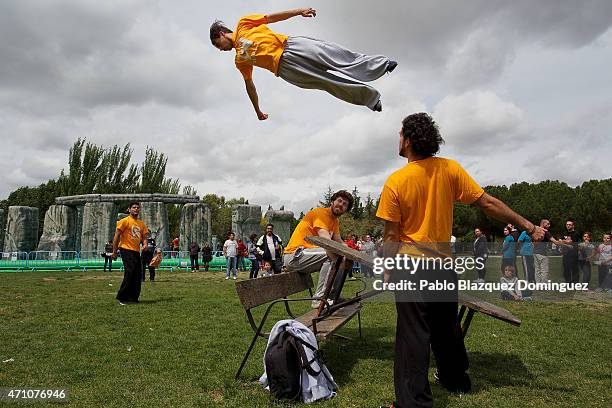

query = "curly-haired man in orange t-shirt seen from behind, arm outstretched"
[[376, 113, 544, 407]]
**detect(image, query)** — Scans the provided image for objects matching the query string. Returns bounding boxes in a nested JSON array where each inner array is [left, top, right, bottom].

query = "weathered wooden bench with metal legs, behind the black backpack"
[[236, 272, 361, 378]]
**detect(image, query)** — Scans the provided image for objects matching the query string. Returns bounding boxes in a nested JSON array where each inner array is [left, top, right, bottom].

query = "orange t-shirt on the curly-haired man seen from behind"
[[376, 157, 484, 247]]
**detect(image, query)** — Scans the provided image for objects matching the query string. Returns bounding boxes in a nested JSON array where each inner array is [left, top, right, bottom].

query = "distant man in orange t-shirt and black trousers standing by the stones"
[[112, 201, 149, 305]]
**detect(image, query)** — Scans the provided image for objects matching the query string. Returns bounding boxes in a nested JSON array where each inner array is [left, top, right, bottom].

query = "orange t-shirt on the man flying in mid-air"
[[233, 14, 287, 80]]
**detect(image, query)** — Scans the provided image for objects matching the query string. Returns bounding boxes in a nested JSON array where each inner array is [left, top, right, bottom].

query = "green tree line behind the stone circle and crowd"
[[0, 138, 612, 244]]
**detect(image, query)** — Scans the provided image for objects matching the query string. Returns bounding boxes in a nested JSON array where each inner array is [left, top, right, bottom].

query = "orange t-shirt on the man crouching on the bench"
[[285, 207, 340, 254]]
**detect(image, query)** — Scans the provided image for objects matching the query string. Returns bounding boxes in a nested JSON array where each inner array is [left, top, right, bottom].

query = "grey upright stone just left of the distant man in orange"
[[81, 202, 117, 253]]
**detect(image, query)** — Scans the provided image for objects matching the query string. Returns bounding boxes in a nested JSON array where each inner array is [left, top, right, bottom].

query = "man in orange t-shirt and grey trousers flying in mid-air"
[[210, 8, 397, 120]]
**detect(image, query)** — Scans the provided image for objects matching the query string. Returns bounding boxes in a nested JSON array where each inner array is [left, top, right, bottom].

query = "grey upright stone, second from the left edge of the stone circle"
[[38, 205, 77, 251]]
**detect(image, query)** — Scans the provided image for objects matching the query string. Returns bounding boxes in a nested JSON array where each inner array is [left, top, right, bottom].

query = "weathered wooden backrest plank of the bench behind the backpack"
[[236, 272, 314, 310]]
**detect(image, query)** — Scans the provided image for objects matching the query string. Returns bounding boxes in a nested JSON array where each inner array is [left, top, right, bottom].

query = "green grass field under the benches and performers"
[[0, 271, 612, 408]]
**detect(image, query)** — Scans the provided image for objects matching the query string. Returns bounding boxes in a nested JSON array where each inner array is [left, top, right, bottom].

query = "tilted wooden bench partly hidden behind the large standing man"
[[306, 237, 521, 337]]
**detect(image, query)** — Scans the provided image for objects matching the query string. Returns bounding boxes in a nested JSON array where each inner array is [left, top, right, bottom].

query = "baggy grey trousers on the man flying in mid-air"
[[278, 37, 389, 109]]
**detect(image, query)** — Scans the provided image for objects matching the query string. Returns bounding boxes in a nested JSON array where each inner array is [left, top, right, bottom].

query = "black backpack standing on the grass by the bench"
[[264, 331, 328, 401]]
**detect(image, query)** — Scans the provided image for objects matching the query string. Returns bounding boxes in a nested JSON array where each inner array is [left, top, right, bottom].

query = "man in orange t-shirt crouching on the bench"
[[283, 190, 353, 308]]
